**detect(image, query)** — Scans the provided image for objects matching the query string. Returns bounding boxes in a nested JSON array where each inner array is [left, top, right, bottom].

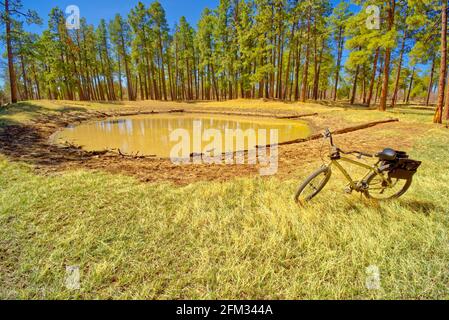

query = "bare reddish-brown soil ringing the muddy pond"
[[0, 106, 427, 185]]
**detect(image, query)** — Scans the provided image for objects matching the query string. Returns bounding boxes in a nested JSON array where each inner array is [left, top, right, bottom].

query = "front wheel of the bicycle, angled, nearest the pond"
[[295, 167, 332, 204]]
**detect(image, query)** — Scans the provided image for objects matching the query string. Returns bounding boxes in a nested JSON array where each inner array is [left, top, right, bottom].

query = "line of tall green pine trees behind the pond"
[[0, 0, 449, 123]]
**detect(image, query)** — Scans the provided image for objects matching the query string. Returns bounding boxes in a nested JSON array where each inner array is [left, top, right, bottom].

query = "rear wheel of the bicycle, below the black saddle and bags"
[[365, 173, 413, 201]]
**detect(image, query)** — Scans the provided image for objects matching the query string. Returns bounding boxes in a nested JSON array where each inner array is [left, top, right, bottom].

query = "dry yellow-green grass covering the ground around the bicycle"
[[0, 102, 449, 299]]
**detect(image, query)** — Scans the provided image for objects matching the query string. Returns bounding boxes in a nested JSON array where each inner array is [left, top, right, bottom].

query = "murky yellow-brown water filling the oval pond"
[[53, 113, 311, 157]]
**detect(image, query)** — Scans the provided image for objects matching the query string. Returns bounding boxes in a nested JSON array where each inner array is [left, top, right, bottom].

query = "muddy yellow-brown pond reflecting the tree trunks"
[[49, 110, 314, 159]]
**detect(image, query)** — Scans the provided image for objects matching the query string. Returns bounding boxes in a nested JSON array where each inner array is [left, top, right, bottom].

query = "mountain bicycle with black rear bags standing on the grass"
[[295, 129, 422, 204]]
